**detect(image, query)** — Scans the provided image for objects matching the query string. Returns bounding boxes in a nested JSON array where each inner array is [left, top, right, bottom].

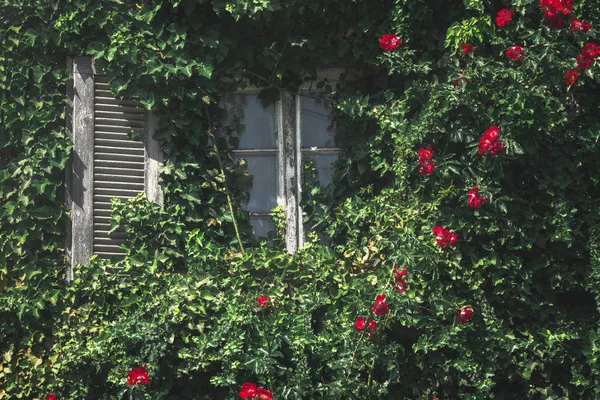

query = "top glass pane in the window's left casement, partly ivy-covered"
[[227, 93, 277, 149]]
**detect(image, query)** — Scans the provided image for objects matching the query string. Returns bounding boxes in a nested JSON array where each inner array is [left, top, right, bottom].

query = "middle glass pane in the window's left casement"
[[236, 154, 277, 212]]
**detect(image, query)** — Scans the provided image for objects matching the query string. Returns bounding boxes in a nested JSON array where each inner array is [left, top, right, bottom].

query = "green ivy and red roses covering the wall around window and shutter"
[[0, 0, 600, 400]]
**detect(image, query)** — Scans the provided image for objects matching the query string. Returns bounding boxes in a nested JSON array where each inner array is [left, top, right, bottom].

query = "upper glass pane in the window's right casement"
[[301, 97, 335, 148]]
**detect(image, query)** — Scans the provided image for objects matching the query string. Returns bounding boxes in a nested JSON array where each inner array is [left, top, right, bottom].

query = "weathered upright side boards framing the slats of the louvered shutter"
[[65, 56, 163, 281]]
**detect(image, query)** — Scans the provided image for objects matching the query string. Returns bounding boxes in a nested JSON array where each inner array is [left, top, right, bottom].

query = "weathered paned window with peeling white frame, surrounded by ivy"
[[226, 87, 340, 253]]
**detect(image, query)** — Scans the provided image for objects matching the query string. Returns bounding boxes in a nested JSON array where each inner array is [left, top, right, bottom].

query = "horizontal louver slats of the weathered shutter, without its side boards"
[[93, 75, 147, 257]]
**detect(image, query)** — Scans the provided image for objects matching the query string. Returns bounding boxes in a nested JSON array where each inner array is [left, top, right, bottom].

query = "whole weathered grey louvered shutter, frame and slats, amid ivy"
[[66, 57, 162, 279]]
